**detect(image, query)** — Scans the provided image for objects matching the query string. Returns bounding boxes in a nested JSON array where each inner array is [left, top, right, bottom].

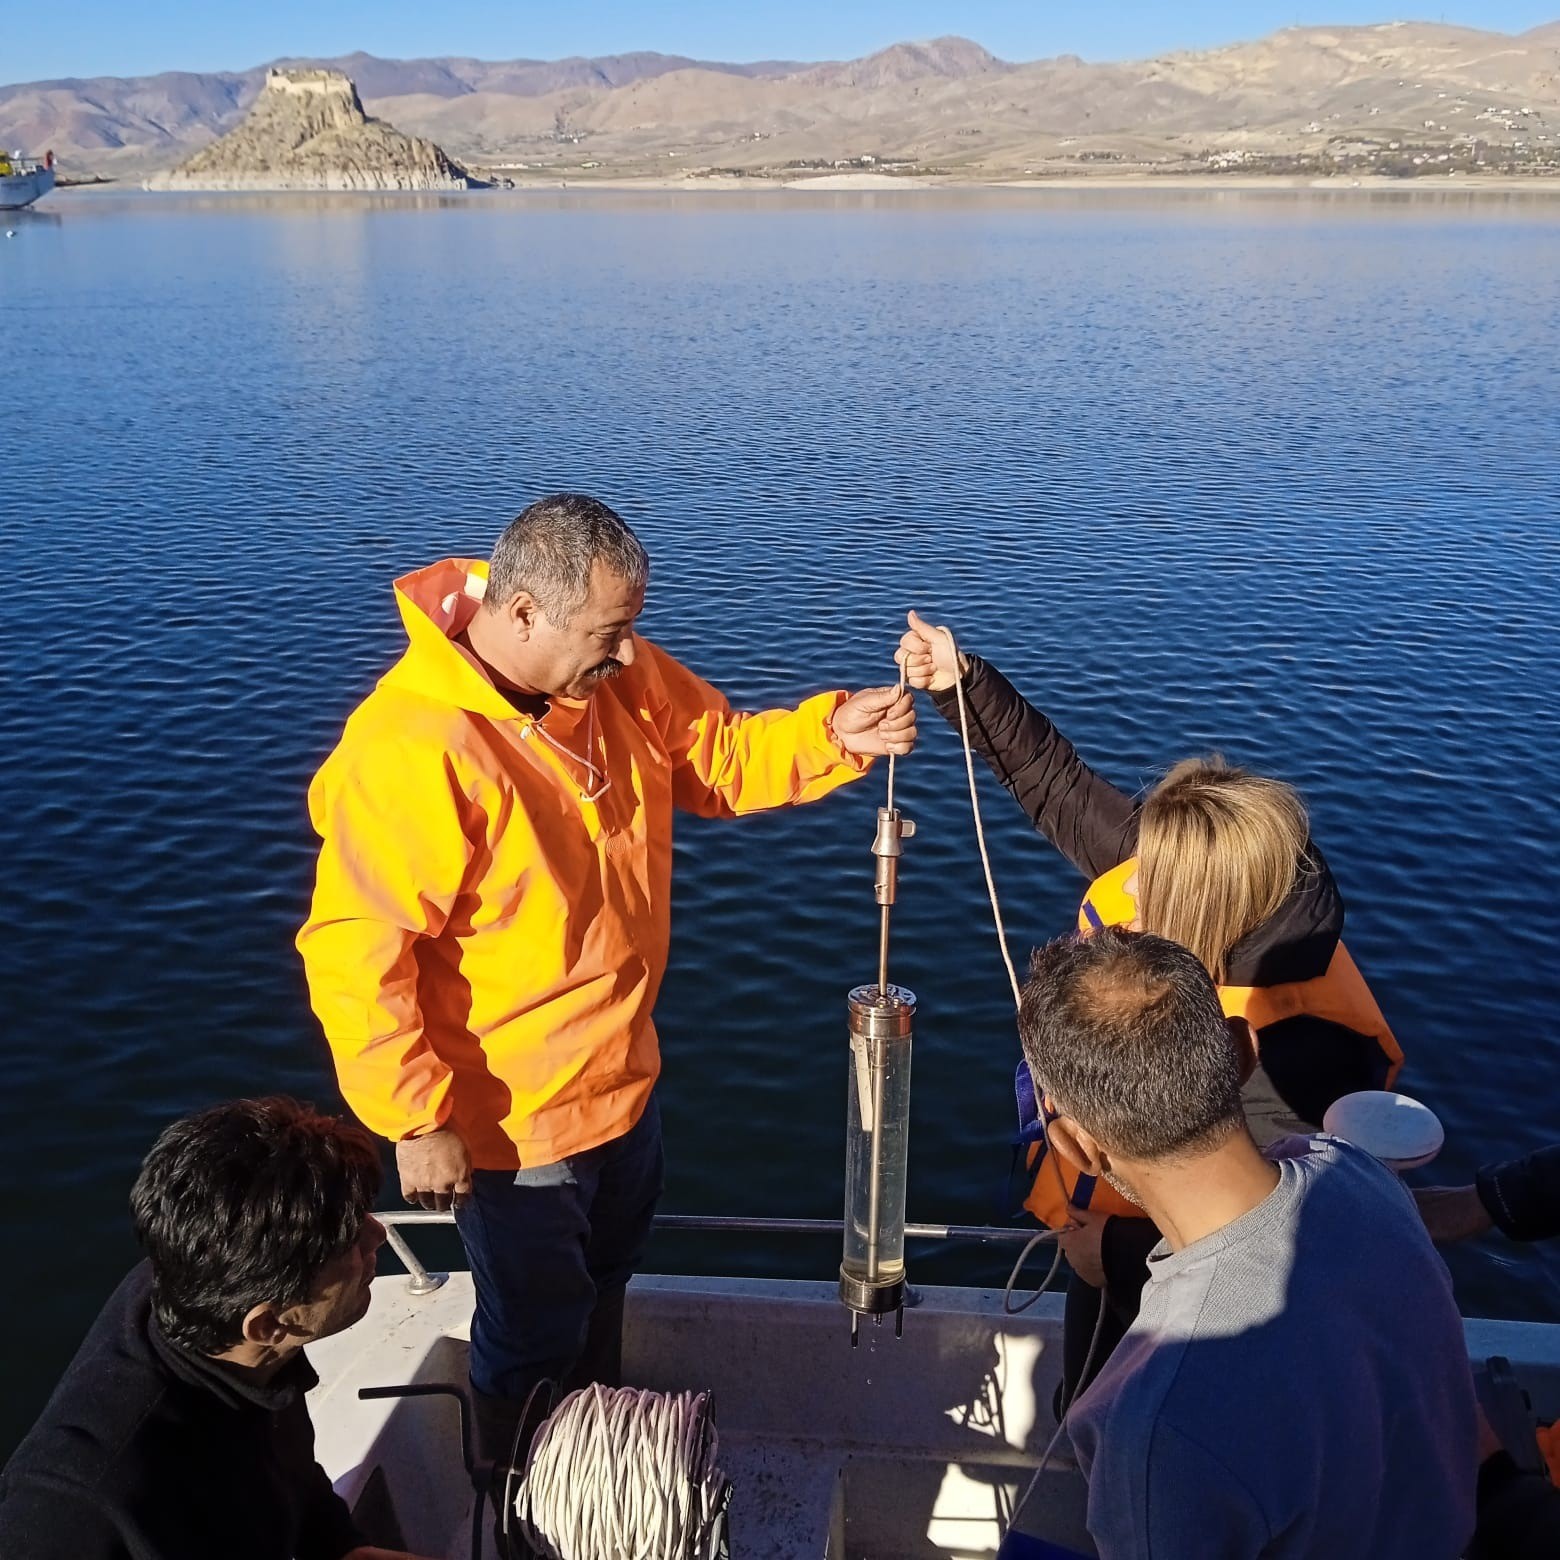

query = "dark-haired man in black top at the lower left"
[[0, 1098, 427, 1560]]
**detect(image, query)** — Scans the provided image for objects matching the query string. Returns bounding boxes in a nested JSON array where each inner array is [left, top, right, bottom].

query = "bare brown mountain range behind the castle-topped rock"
[[0, 22, 1560, 178]]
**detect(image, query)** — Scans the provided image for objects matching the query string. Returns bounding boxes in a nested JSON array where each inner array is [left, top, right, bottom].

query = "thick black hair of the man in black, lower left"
[[129, 1095, 381, 1354]]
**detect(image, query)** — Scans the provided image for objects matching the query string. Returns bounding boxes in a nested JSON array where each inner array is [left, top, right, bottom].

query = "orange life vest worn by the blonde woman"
[[1023, 856, 1402, 1229]]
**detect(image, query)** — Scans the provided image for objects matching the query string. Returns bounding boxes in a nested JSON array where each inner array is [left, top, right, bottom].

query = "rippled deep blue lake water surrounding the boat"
[[0, 192, 1560, 1451]]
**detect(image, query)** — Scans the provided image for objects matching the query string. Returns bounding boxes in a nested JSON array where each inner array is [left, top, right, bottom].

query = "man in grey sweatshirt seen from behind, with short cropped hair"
[[1019, 928, 1477, 1560]]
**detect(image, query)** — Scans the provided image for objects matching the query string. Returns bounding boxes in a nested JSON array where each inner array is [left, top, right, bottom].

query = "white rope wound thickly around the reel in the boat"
[[516, 1385, 730, 1560]]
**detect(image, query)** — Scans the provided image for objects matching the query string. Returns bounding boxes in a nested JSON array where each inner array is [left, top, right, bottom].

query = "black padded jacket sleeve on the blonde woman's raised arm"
[[931, 655, 1137, 878]]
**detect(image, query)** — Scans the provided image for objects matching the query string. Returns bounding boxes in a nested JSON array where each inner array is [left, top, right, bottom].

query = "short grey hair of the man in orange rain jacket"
[[487, 493, 651, 629]]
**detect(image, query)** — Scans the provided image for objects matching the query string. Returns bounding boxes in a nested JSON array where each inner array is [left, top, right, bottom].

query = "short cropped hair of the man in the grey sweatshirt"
[[1019, 927, 1243, 1159]]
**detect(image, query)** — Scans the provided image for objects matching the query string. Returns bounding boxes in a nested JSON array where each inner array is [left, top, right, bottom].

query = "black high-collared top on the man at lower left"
[[0, 1264, 365, 1560]]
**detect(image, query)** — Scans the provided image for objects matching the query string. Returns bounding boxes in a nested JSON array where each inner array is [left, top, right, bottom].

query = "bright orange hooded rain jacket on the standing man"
[[298, 558, 867, 1170]]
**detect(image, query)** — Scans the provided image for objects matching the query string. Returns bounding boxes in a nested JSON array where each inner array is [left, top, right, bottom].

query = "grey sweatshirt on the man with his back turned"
[[1069, 1136, 1477, 1560]]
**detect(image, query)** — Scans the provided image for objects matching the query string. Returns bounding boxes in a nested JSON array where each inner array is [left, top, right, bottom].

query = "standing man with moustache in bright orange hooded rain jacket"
[[298, 493, 916, 1457]]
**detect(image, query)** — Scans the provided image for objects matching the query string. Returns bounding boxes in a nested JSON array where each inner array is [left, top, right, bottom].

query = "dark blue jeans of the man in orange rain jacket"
[[456, 1094, 665, 1401]]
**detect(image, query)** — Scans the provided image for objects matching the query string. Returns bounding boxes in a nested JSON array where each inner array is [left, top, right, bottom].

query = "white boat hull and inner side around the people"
[[309, 1273, 1560, 1560]]
